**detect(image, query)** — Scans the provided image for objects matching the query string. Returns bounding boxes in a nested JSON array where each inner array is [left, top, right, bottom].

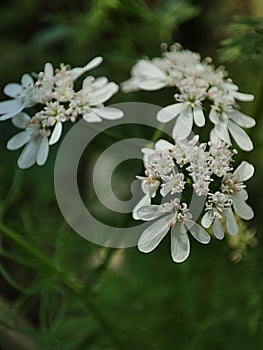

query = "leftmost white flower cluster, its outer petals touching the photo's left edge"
[[0, 57, 123, 168]]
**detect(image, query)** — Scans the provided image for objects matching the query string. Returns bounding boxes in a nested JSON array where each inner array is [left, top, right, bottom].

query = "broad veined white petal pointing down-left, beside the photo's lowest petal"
[[138, 215, 171, 253]]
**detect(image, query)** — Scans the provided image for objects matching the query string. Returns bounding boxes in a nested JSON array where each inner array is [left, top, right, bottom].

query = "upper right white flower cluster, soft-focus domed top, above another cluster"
[[122, 44, 255, 151]]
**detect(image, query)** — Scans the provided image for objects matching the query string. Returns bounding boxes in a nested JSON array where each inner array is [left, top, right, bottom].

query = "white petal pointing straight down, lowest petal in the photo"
[[171, 222, 190, 263]]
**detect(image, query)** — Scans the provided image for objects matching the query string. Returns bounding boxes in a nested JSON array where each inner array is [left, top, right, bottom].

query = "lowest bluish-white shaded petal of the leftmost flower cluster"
[[17, 135, 42, 169]]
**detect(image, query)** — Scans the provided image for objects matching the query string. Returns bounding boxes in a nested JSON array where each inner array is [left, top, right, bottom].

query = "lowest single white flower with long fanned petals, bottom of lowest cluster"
[[137, 199, 210, 263]]
